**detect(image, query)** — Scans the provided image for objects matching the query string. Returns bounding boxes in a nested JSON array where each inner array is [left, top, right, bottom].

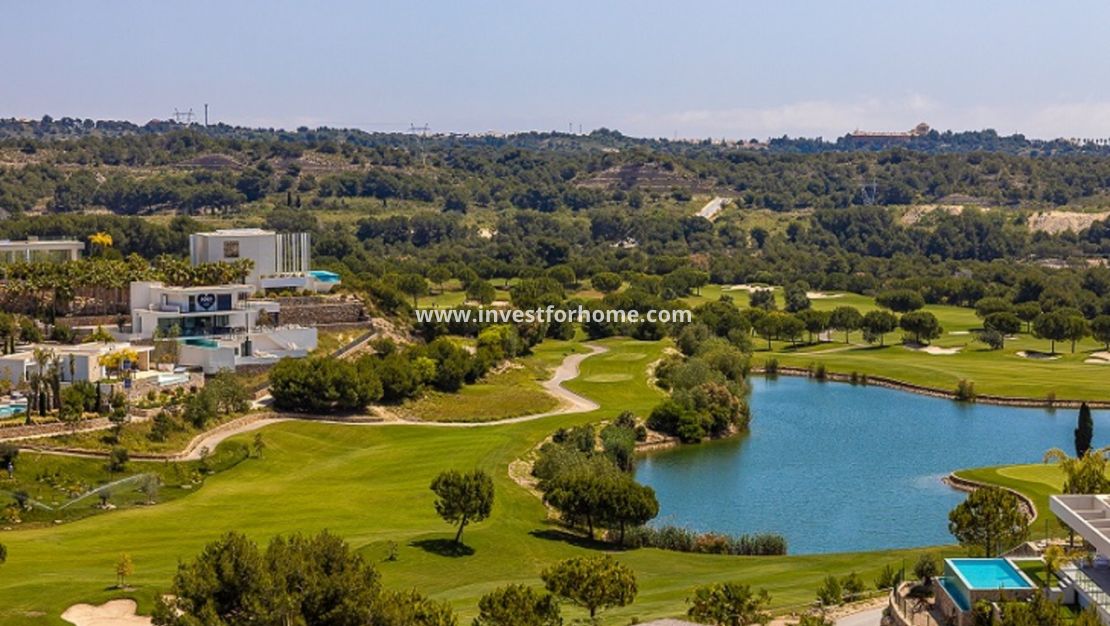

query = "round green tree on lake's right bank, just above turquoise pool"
[[948, 486, 1029, 556]]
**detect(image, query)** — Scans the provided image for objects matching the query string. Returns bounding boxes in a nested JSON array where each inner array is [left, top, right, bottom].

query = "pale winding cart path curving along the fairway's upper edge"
[[175, 344, 608, 461]]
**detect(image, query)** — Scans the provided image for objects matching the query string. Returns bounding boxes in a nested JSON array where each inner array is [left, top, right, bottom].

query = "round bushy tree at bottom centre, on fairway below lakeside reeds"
[[539, 555, 637, 619]]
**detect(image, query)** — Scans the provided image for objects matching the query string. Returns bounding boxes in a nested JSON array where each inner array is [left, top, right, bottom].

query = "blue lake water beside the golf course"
[[636, 376, 1110, 554]]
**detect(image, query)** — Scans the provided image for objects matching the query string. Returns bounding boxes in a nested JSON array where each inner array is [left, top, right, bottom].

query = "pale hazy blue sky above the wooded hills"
[[0, 0, 1110, 139]]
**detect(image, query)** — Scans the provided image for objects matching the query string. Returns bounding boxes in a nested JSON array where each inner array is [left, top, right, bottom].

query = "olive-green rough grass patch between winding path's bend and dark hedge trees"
[[397, 341, 585, 422]]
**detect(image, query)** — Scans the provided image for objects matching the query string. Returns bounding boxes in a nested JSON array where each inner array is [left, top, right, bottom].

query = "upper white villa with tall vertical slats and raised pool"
[[189, 229, 340, 293]]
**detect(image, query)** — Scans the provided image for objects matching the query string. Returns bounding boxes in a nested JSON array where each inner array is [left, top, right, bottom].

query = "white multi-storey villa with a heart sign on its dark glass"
[[131, 281, 316, 374]]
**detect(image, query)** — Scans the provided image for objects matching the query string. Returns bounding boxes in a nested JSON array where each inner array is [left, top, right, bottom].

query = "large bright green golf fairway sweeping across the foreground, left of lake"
[[0, 340, 945, 626]]
